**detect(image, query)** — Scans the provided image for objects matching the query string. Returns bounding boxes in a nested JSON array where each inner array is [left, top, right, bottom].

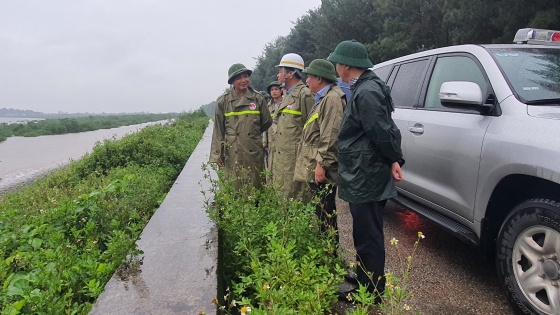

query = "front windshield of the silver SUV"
[[488, 48, 560, 105]]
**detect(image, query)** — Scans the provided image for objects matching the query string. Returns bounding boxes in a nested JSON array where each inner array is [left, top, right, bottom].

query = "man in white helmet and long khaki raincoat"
[[272, 54, 315, 199]]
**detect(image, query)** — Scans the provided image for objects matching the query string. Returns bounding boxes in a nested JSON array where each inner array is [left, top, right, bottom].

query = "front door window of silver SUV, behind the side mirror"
[[424, 56, 487, 110]]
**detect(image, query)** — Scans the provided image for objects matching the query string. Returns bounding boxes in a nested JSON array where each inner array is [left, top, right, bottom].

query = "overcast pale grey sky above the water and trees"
[[0, 0, 321, 113]]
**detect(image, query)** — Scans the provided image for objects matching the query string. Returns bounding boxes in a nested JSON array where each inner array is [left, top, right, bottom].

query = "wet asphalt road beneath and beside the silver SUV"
[[336, 200, 513, 315]]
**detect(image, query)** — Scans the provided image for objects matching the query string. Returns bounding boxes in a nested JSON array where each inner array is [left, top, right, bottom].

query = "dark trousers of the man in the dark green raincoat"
[[349, 200, 387, 294]]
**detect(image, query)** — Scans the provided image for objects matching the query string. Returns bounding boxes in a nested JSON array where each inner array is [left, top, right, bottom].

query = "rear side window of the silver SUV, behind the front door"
[[391, 59, 429, 107]]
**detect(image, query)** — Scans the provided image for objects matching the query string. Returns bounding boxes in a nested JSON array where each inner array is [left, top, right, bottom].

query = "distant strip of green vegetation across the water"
[[0, 113, 179, 142]]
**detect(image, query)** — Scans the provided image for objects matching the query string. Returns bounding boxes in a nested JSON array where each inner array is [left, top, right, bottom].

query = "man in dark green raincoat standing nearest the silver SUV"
[[329, 40, 404, 300]]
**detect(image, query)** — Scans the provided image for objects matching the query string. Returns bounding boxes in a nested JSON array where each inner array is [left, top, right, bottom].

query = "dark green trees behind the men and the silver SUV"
[[251, 0, 560, 91]]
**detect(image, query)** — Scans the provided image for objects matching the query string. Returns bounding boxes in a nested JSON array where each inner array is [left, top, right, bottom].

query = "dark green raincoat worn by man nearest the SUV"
[[338, 70, 404, 203]]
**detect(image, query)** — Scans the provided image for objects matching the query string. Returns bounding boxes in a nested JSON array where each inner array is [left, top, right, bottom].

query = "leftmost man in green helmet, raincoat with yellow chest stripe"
[[210, 63, 272, 188]]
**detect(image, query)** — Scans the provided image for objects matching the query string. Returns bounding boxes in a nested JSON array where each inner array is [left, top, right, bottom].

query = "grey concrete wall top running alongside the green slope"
[[90, 122, 218, 315]]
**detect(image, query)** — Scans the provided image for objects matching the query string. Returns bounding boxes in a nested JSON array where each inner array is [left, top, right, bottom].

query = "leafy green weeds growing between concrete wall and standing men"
[[208, 170, 344, 314]]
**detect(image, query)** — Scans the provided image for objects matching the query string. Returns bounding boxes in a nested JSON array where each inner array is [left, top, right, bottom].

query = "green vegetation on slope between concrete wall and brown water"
[[0, 110, 208, 315]]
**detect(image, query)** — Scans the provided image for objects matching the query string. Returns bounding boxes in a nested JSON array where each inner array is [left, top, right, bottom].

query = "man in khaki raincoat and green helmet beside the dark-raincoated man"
[[294, 59, 346, 240]]
